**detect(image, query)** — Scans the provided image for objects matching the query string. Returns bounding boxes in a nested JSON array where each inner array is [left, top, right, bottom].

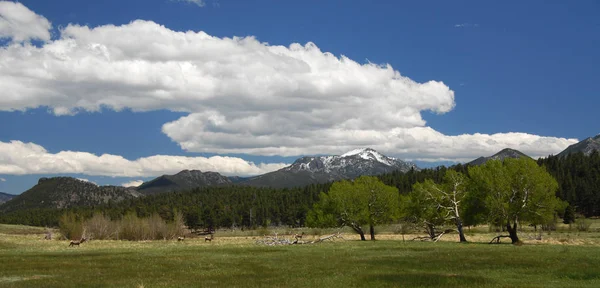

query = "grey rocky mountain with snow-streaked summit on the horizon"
[[240, 148, 418, 187]]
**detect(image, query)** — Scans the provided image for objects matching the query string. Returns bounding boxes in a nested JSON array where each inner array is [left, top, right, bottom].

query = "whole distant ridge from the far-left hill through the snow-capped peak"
[[0, 148, 418, 212]]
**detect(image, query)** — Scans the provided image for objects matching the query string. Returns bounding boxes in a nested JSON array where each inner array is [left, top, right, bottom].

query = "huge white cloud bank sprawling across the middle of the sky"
[[0, 2, 577, 169]]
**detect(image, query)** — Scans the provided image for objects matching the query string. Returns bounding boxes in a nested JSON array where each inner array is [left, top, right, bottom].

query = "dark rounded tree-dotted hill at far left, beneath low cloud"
[[0, 177, 141, 212]]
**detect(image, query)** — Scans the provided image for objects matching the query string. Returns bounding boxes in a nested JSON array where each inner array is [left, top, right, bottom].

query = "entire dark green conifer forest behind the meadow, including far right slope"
[[0, 151, 600, 229]]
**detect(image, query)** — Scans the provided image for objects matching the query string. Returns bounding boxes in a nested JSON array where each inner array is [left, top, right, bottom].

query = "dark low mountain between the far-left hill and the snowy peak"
[[136, 170, 232, 195]]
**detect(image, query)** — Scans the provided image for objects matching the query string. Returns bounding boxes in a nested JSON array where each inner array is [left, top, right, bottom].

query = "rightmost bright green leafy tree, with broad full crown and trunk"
[[469, 158, 560, 244]]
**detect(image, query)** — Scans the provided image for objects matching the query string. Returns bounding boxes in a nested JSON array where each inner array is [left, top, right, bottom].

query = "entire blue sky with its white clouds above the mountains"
[[0, 0, 600, 194]]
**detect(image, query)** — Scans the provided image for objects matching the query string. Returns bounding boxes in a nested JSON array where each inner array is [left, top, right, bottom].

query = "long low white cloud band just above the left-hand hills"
[[0, 141, 285, 177]]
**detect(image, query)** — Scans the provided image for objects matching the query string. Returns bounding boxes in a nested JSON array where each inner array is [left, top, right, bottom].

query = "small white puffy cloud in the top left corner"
[[0, 1, 52, 42]]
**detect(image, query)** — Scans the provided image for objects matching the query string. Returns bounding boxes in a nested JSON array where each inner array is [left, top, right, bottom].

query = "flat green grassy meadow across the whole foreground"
[[0, 225, 600, 287]]
